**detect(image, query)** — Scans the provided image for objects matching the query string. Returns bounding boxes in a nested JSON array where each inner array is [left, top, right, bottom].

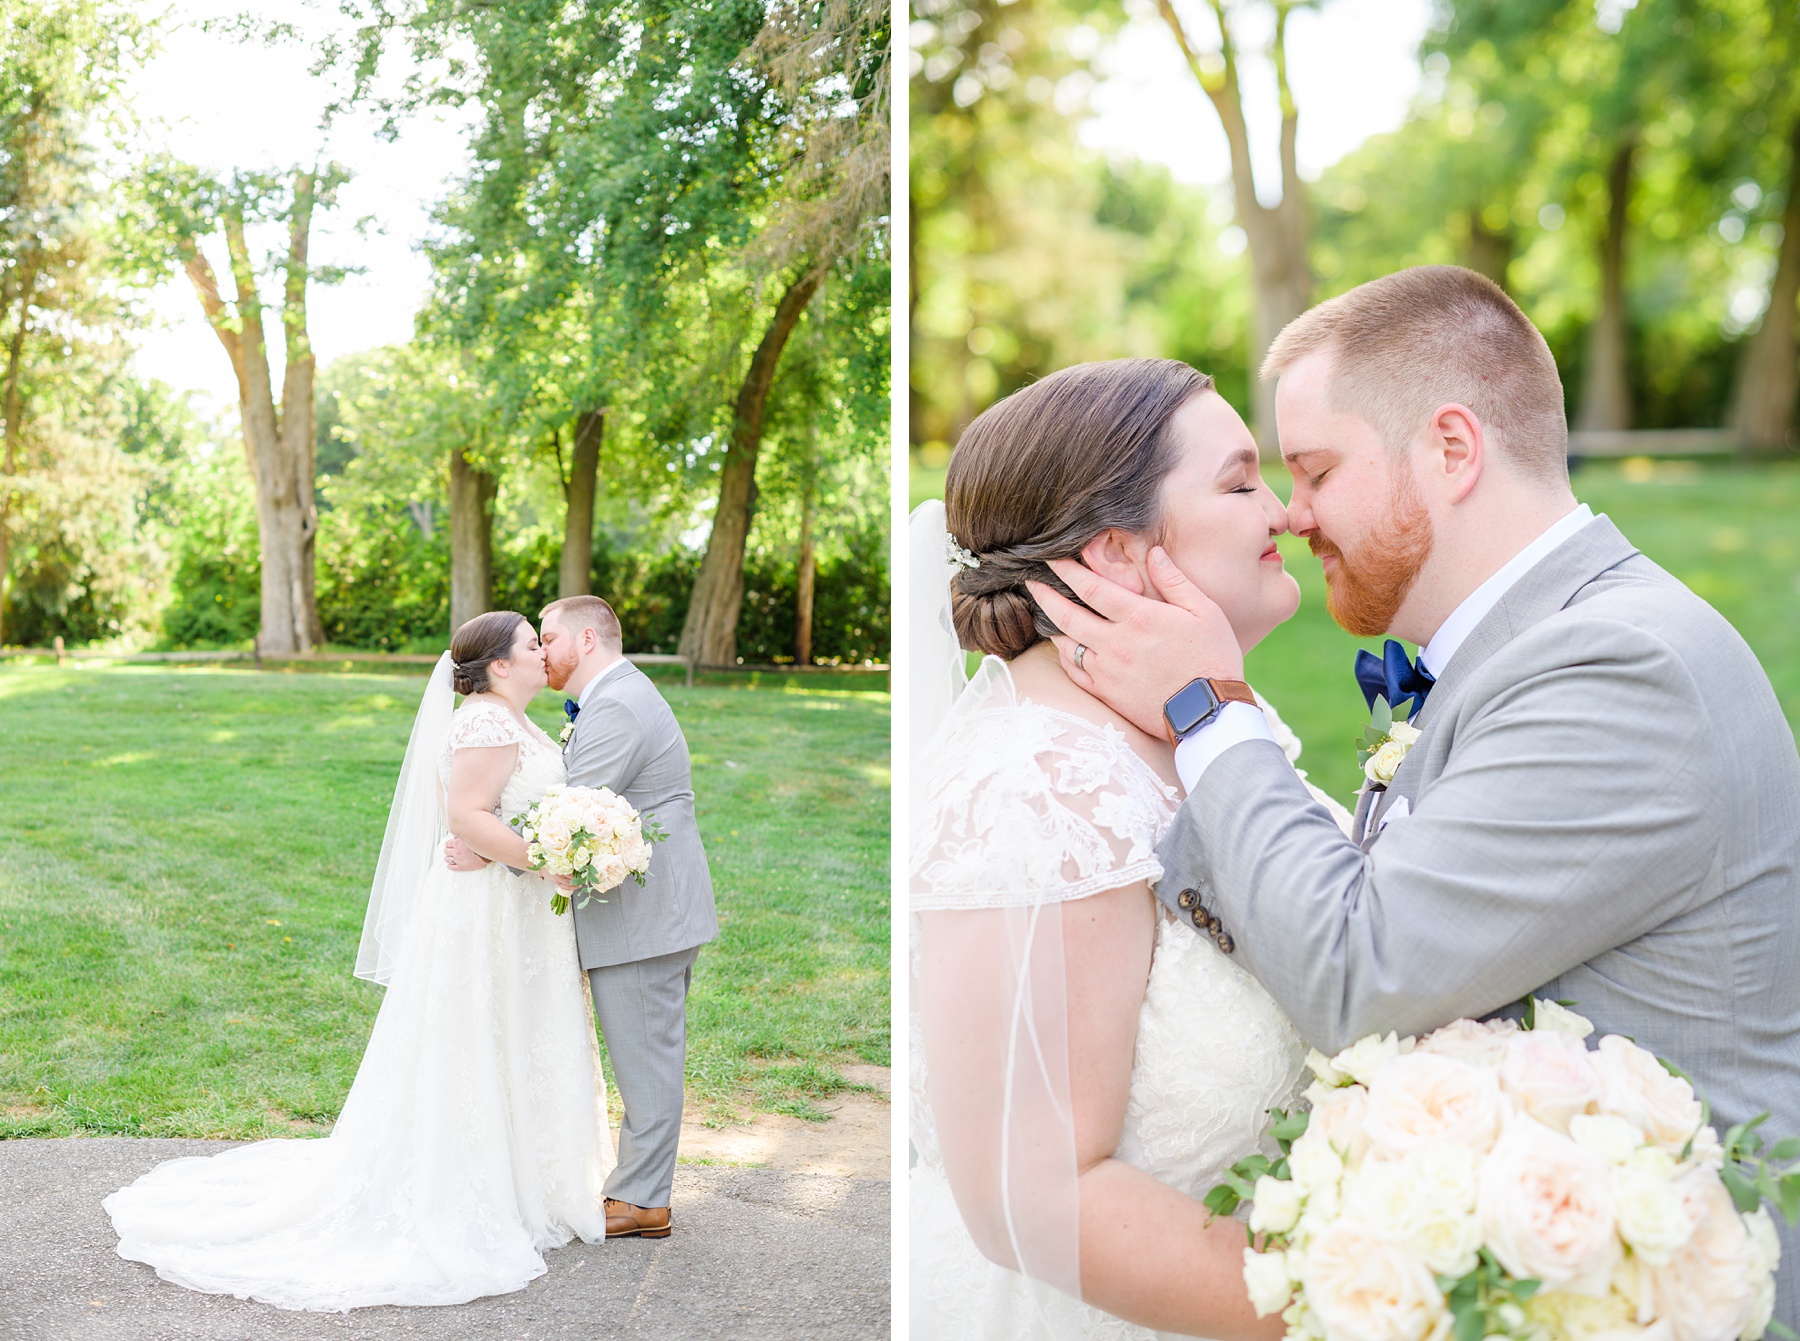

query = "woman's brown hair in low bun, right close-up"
[[943, 358, 1213, 661]]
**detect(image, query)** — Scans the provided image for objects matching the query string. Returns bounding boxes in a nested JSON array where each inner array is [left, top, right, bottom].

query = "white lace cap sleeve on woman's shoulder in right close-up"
[[909, 702, 1175, 911]]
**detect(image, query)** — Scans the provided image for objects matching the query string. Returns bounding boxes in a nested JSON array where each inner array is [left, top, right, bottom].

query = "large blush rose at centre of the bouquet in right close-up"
[[1476, 1118, 1620, 1294]]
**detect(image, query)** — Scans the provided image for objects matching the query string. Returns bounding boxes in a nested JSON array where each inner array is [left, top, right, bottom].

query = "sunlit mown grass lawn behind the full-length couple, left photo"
[[0, 666, 889, 1138]]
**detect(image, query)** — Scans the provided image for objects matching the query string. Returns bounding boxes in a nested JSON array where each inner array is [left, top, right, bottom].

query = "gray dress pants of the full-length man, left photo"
[[587, 945, 700, 1206]]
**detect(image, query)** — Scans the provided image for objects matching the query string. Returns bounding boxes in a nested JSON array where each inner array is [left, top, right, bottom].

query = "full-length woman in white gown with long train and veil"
[[104, 610, 616, 1310]]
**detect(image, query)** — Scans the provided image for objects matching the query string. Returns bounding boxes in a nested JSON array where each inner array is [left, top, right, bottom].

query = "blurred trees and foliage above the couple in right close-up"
[[909, 0, 1800, 471]]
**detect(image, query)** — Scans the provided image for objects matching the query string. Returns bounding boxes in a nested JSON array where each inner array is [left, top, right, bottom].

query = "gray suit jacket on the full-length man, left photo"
[[563, 666, 718, 968]]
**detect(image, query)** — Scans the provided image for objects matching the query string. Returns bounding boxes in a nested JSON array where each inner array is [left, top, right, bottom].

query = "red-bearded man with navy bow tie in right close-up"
[[1031, 266, 1800, 1327]]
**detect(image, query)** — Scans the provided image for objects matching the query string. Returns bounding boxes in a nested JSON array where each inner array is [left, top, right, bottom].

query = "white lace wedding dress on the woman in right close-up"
[[909, 657, 1350, 1341]]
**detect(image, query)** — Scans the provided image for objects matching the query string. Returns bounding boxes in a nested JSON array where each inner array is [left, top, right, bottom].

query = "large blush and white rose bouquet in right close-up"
[[1206, 1001, 1800, 1341]]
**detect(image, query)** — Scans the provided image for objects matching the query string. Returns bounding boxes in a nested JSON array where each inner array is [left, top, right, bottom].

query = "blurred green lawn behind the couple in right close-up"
[[911, 450, 1800, 801]]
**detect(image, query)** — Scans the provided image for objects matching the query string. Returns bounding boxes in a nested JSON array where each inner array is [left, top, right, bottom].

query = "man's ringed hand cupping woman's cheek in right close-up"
[[1026, 545, 1244, 736]]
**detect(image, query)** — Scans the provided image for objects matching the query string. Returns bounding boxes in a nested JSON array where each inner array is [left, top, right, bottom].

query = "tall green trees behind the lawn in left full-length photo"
[[0, 0, 891, 664]]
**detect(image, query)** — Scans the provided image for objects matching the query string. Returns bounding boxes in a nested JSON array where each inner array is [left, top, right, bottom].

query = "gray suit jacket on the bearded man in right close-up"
[[1157, 517, 1800, 1330]]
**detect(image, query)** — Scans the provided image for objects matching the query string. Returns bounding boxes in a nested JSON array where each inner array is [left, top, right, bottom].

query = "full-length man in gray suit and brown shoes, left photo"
[[452, 596, 718, 1238]]
